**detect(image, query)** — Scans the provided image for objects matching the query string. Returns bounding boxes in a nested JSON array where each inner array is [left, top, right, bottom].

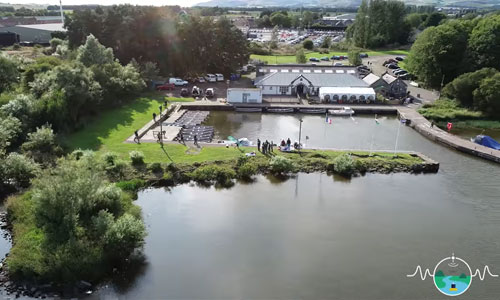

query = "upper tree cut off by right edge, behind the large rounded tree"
[[468, 15, 500, 69]]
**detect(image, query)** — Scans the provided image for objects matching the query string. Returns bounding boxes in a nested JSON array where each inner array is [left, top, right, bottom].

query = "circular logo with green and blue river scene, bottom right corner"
[[434, 254, 472, 296]]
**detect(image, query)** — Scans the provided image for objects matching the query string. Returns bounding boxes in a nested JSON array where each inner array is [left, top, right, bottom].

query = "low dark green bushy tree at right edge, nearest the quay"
[[474, 72, 500, 116]]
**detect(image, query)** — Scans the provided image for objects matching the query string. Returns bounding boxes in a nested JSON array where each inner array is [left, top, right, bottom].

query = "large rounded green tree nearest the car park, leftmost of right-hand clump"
[[407, 21, 470, 88]]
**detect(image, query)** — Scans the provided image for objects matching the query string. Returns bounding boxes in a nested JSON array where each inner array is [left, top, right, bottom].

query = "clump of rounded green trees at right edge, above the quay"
[[407, 14, 500, 115]]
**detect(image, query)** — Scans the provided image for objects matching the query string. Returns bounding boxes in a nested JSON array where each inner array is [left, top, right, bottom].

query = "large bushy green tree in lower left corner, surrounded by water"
[[7, 153, 145, 282]]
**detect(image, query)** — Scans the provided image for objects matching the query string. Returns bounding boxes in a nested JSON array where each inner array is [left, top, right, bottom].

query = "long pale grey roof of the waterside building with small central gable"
[[255, 72, 368, 87]]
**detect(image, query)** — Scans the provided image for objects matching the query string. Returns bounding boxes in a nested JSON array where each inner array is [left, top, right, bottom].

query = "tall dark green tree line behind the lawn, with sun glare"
[[65, 5, 249, 76]]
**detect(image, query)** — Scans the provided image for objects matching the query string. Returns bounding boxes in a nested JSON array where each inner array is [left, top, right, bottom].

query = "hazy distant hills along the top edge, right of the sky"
[[196, 0, 500, 8]]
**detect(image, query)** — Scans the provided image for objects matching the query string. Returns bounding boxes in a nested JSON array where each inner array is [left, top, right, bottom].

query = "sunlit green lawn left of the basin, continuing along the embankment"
[[62, 93, 421, 165]]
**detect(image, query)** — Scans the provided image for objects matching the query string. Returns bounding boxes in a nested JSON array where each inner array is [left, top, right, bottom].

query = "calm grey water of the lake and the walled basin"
[[2, 112, 500, 299]]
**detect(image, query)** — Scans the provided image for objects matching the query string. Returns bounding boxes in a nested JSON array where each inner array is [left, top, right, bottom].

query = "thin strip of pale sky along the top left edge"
[[0, 0, 201, 7]]
